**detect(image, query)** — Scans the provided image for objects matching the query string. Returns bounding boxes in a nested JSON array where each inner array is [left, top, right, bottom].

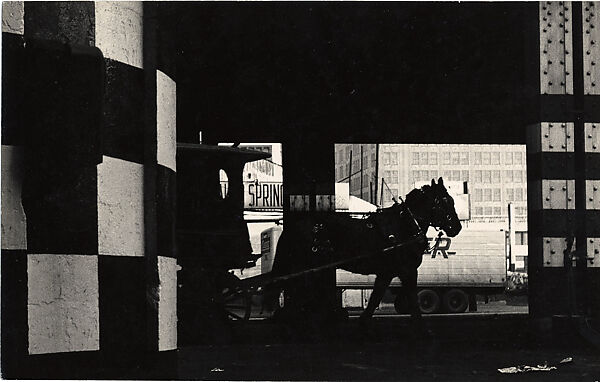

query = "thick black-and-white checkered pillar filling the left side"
[[2, 2, 177, 379]]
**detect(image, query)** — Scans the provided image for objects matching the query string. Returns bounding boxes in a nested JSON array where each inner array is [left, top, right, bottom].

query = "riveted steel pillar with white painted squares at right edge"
[[527, 1, 600, 317]]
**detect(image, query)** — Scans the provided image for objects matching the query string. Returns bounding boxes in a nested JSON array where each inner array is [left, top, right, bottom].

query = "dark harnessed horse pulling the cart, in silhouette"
[[272, 178, 462, 328]]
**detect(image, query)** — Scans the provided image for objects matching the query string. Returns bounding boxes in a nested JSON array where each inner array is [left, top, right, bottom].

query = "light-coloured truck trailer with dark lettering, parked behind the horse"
[[261, 226, 507, 314]]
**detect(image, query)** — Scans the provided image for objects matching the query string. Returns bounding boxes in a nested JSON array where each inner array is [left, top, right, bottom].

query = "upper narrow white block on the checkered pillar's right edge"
[[156, 70, 177, 171]]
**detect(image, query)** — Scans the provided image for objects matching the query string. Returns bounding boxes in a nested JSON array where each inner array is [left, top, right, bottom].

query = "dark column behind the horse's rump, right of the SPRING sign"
[[283, 129, 341, 328]]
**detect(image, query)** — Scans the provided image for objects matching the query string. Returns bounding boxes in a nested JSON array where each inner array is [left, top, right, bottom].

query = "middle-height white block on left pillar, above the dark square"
[[97, 156, 144, 256]]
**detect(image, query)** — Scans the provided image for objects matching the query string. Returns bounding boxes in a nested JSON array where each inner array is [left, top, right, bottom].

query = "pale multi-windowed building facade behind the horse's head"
[[335, 144, 527, 222]]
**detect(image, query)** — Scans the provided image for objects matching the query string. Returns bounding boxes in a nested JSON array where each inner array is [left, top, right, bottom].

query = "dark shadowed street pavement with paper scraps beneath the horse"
[[178, 303, 600, 381]]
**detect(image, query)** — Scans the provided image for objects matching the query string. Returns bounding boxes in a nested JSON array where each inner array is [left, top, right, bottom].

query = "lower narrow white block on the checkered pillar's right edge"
[[158, 256, 178, 351]]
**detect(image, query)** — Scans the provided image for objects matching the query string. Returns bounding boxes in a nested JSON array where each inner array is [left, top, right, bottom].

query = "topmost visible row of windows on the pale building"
[[410, 151, 524, 165]]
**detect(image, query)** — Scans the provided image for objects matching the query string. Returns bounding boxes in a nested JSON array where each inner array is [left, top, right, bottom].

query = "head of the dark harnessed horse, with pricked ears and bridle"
[[426, 178, 462, 237]]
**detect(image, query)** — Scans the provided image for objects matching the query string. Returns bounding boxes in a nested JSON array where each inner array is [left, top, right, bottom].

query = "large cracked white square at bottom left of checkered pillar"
[[27, 254, 100, 354]]
